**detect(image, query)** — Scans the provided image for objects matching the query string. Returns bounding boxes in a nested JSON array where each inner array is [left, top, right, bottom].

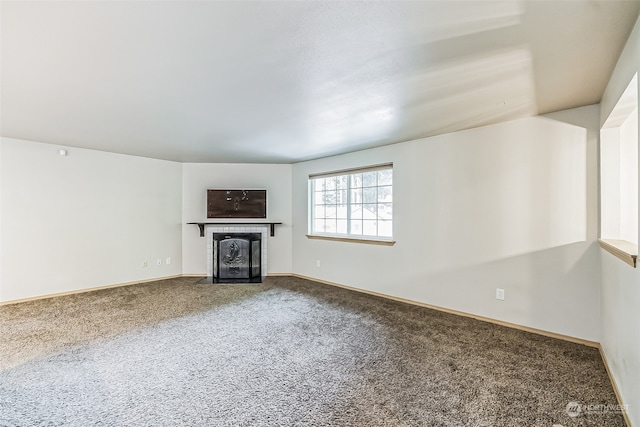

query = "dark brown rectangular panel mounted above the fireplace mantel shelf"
[[207, 190, 267, 218]]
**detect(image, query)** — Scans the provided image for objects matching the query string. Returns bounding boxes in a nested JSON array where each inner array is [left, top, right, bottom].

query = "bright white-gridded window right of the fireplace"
[[309, 164, 393, 240]]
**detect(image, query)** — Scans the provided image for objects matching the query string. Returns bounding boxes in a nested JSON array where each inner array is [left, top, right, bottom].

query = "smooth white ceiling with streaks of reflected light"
[[0, 0, 640, 163]]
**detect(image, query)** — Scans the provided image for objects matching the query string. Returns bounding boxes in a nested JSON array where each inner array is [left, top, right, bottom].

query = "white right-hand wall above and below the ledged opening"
[[600, 13, 640, 426]]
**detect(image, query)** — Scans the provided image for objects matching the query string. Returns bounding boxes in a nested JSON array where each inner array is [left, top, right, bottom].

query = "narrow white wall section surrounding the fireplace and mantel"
[[182, 163, 291, 275]]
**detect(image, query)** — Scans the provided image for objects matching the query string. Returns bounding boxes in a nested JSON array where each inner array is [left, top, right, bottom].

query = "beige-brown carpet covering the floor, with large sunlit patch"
[[0, 277, 625, 427]]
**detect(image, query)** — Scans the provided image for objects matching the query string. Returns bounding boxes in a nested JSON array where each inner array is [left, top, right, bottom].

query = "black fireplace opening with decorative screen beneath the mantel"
[[212, 232, 262, 283]]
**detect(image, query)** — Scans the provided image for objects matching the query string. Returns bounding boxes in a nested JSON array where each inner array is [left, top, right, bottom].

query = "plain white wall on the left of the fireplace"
[[0, 138, 182, 301]]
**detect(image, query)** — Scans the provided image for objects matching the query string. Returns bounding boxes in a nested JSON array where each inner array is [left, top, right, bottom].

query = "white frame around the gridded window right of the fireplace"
[[306, 162, 395, 241]]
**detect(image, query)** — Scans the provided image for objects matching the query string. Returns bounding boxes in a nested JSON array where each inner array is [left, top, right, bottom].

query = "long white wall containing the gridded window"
[[293, 106, 600, 341]]
